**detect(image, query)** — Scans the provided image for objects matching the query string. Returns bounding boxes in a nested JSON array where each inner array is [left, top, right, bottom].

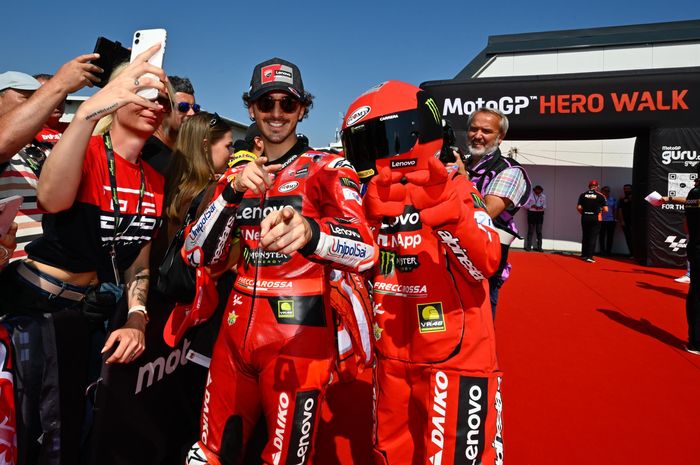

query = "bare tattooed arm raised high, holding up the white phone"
[[37, 44, 166, 213]]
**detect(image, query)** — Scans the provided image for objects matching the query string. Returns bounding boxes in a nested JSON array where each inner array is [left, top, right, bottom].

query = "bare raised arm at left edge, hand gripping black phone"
[[0, 53, 102, 163]]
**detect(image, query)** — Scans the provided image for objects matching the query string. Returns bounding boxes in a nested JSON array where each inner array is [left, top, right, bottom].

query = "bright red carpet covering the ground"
[[315, 252, 700, 465]]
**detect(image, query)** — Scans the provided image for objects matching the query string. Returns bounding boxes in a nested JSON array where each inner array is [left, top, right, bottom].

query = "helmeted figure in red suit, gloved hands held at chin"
[[343, 81, 503, 465]]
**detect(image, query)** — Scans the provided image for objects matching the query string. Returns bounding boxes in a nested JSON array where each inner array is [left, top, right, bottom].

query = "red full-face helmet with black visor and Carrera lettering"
[[342, 81, 443, 182]]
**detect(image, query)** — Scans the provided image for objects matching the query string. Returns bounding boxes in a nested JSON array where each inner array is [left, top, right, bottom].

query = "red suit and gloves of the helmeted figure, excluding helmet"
[[364, 160, 503, 465]]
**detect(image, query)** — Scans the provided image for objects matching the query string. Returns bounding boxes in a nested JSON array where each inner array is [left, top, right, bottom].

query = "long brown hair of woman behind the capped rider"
[[165, 111, 231, 222]]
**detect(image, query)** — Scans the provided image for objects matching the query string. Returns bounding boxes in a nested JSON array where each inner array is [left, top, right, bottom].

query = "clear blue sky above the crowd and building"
[[0, 0, 700, 146]]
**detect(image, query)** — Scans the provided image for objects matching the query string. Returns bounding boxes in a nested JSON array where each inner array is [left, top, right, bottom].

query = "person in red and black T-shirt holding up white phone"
[[0, 45, 171, 464]]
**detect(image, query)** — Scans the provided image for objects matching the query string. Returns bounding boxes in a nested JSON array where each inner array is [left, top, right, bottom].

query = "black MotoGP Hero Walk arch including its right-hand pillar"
[[421, 68, 700, 266]]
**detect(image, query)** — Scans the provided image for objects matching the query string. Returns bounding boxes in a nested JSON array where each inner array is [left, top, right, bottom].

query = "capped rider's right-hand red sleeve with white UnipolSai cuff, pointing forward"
[[300, 158, 379, 271]]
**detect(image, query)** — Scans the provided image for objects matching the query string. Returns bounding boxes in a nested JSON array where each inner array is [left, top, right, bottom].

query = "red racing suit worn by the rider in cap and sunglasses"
[[185, 144, 378, 465]]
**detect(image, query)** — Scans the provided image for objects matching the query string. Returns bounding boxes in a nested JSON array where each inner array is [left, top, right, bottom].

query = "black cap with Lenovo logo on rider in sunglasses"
[[248, 58, 306, 102]]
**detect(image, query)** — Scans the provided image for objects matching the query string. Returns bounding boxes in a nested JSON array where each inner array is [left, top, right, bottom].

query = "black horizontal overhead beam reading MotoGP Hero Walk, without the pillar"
[[421, 68, 700, 140]]
